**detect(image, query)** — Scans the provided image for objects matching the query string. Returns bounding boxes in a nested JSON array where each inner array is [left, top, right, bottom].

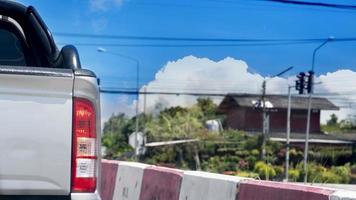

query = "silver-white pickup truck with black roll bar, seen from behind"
[[0, 0, 101, 200]]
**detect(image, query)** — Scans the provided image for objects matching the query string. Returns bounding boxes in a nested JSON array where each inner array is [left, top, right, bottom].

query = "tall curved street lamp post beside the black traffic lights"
[[304, 37, 334, 183]]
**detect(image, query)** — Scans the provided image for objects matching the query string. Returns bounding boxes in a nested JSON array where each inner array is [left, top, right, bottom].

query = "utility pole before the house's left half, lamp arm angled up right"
[[259, 67, 293, 160]]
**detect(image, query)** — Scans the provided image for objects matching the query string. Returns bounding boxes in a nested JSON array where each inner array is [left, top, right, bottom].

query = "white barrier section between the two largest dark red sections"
[[179, 171, 246, 200]]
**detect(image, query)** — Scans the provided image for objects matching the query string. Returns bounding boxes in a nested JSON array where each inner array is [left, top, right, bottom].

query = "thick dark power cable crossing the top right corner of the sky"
[[255, 0, 356, 10]]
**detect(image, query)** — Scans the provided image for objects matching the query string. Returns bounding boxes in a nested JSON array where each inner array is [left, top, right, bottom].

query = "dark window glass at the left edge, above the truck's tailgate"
[[0, 29, 26, 66]]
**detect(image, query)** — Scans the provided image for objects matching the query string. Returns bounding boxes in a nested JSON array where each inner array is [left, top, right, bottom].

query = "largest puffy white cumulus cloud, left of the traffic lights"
[[140, 56, 263, 111]]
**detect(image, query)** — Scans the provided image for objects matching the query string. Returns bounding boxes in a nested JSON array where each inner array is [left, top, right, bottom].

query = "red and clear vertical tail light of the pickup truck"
[[72, 98, 98, 192]]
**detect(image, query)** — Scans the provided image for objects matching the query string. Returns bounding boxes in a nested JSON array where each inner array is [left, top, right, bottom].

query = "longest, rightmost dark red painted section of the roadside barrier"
[[237, 180, 334, 200]]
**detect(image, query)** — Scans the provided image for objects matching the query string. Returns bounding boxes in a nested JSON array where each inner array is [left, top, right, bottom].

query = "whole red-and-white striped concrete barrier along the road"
[[101, 160, 356, 200]]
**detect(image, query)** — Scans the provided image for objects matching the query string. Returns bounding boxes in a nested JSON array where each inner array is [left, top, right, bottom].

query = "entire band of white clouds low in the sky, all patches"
[[104, 56, 356, 123]]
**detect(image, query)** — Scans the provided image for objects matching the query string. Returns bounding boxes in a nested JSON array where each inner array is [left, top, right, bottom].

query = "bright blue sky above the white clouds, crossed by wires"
[[16, 0, 356, 122]]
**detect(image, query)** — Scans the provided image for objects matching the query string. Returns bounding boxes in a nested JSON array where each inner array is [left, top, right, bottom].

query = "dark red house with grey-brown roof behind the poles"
[[218, 94, 339, 133]]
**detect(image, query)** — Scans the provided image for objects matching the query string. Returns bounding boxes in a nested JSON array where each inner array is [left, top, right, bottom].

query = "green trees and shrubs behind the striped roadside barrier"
[[102, 99, 356, 183]]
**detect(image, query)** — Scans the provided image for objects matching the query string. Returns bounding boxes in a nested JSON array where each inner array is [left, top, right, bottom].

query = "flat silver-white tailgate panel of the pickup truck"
[[0, 67, 74, 195]]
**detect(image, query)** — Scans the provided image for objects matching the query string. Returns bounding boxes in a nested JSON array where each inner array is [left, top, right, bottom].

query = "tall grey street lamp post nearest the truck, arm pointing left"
[[97, 47, 140, 154]]
